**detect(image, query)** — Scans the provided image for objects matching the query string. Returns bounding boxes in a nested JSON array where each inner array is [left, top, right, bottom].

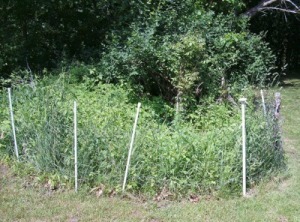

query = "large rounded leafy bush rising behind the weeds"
[[96, 10, 275, 107]]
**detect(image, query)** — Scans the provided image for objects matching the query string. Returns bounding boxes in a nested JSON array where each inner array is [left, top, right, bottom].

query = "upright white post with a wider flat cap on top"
[[240, 98, 247, 197]]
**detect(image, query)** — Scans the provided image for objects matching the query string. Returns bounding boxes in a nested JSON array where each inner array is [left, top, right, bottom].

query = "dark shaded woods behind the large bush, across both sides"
[[0, 0, 299, 82]]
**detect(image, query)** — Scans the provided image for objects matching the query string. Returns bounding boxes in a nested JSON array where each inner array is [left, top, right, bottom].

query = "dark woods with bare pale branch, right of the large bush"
[[244, 0, 300, 71]]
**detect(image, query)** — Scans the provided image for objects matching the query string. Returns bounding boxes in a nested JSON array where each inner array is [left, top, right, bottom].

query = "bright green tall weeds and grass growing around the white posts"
[[0, 75, 284, 195]]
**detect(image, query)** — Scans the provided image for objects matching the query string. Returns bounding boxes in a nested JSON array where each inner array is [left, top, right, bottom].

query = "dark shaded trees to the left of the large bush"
[[0, 0, 197, 78]]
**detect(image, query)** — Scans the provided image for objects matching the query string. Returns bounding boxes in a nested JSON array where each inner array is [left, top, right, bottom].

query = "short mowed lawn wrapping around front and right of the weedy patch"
[[0, 79, 300, 222]]
